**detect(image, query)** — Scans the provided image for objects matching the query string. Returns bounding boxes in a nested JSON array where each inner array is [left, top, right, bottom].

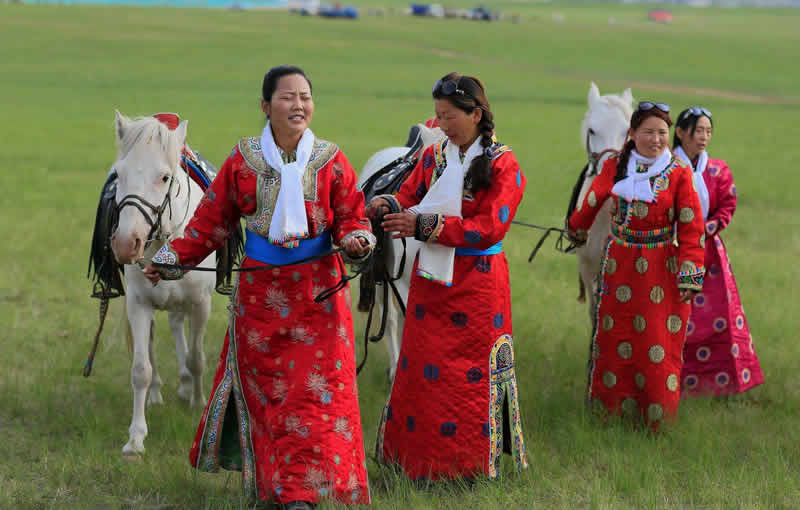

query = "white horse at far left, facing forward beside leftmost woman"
[[111, 112, 216, 455]]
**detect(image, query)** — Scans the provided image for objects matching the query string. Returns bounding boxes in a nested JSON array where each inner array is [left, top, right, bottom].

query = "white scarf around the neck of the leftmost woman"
[[261, 121, 314, 248]]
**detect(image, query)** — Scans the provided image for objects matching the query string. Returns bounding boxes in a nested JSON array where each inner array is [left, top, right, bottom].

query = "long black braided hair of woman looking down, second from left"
[[433, 73, 494, 193]]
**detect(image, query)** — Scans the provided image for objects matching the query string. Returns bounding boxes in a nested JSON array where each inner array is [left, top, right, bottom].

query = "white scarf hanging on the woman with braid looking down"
[[412, 136, 483, 286]]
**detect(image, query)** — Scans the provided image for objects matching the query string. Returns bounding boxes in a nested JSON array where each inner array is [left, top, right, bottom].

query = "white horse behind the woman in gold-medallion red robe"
[[576, 82, 633, 324]]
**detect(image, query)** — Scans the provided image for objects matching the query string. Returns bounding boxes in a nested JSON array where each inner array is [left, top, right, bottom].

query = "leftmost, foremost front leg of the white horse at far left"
[[122, 300, 153, 455]]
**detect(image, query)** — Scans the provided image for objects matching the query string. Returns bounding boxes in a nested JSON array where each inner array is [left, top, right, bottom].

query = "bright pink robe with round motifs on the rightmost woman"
[[681, 159, 764, 397]]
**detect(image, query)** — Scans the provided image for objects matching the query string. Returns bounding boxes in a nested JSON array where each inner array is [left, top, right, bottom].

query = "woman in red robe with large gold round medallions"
[[569, 101, 705, 430]]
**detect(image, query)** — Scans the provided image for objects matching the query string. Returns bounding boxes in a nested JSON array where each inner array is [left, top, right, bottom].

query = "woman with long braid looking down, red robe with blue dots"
[[367, 73, 527, 480]]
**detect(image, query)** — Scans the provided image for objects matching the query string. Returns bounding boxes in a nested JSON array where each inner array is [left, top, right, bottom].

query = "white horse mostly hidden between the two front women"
[[358, 124, 444, 379]]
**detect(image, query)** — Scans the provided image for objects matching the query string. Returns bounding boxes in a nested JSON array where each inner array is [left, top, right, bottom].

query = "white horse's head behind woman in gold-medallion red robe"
[[581, 82, 633, 164]]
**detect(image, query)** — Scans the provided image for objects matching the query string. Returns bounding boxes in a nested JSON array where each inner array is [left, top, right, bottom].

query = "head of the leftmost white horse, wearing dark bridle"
[[111, 112, 188, 264]]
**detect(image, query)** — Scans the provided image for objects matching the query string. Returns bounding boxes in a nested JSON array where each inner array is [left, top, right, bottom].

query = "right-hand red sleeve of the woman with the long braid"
[[436, 151, 527, 250]]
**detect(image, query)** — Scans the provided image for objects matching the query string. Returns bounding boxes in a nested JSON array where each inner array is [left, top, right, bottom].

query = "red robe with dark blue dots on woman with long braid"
[[377, 140, 527, 480]]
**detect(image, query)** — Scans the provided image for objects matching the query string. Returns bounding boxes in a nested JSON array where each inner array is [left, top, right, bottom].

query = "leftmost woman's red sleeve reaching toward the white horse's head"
[[170, 147, 242, 266]]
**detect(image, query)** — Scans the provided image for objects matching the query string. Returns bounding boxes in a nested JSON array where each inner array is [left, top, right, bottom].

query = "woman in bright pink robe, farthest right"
[[672, 106, 764, 396]]
